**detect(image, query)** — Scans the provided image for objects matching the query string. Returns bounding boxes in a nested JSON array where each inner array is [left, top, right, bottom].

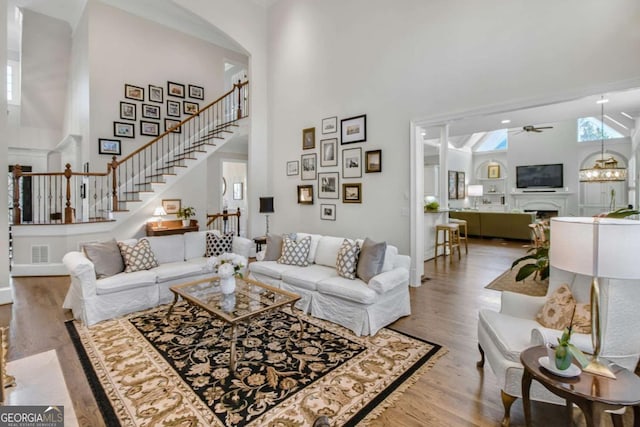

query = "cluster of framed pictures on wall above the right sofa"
[[286, 114, 380, 221]]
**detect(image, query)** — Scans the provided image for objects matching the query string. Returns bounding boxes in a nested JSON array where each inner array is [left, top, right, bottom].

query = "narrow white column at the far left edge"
[[0, 0, 12, 304]]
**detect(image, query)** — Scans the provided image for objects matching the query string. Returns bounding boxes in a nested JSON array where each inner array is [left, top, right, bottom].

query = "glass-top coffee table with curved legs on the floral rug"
[[167, 276, 303, 371]]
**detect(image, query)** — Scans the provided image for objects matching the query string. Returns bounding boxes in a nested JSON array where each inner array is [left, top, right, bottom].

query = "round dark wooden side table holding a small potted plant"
[[520, 346, 640, 427]]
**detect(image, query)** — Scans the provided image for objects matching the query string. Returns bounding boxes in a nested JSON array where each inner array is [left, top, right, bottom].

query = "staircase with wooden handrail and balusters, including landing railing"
[[11, 81, 249, 225]]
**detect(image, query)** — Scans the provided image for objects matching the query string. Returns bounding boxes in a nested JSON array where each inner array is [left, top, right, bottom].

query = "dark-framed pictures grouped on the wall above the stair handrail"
[[98, 80, 208, 155]]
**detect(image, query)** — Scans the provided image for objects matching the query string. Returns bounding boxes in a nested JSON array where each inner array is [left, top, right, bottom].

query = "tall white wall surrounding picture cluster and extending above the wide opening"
[[268, 0, 640, 253]]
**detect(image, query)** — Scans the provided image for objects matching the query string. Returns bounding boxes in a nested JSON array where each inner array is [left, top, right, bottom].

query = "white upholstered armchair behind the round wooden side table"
[[478, 266, 640, 426]]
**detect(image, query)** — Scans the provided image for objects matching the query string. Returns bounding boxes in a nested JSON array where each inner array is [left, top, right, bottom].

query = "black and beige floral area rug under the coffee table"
[[67, 303, 446, 426]]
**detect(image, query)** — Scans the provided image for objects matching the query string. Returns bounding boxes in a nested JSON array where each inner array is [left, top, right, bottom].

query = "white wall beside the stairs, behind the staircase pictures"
[[83, 1, 247, 170]]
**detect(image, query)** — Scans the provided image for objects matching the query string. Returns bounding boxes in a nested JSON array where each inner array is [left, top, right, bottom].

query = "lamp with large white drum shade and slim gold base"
[[549, 217, 640, 378]]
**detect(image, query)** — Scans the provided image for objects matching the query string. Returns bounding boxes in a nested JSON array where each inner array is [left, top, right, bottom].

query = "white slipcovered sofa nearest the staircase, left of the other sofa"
[[62, 231, 253, 325]]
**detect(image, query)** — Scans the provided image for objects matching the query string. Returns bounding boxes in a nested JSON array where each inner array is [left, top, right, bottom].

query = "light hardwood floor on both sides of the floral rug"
[[0, 239, 630, 427]]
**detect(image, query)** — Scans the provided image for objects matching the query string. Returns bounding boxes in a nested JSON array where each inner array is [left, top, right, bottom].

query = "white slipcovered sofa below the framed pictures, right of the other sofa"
[[249, 233, 411, 336]]
